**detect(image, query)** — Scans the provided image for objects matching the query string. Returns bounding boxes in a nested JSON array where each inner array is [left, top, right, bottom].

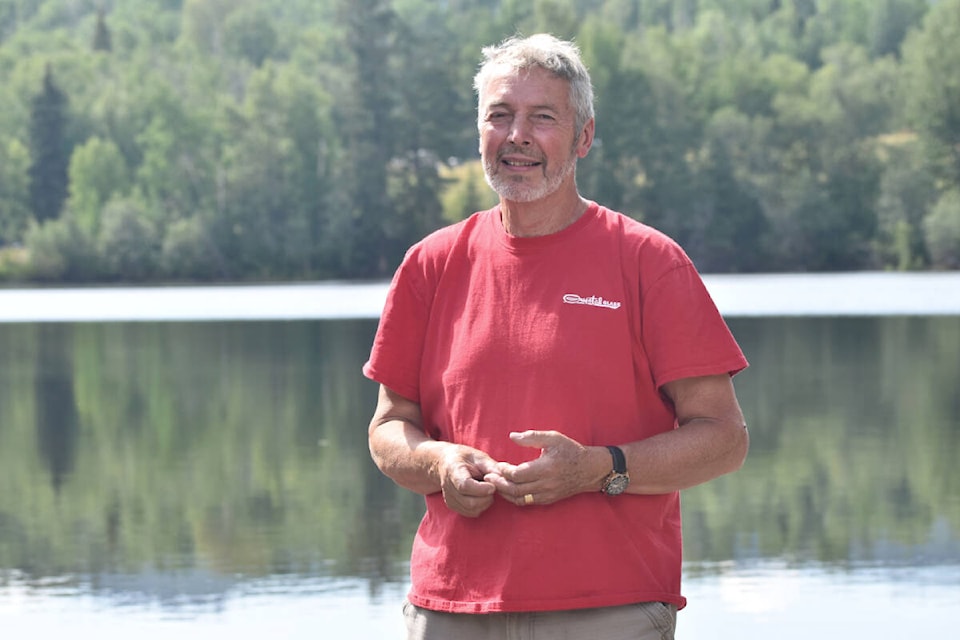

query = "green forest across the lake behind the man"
[[0, 0, 960, 285]]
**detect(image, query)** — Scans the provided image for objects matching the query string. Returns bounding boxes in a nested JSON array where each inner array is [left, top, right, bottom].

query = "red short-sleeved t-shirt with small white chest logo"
[[363, 203, 747, 613]]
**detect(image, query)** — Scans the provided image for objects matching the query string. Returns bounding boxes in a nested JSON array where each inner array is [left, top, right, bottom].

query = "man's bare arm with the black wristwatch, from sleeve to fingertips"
[[489, 374, 750, 505]]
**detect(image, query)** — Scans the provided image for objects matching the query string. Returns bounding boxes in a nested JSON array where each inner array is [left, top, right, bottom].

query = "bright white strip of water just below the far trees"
[[0, 271, 960, 323]]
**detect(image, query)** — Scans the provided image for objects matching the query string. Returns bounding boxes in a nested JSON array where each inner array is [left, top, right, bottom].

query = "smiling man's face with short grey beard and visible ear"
[[480, 67, 593, 202]]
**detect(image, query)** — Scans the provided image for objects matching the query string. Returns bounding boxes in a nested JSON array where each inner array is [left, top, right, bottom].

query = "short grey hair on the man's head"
[[473, 33, 593, 132]]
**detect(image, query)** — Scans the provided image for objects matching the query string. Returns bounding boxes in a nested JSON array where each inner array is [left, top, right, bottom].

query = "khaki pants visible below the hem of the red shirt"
[[403, 602, 677, 640]]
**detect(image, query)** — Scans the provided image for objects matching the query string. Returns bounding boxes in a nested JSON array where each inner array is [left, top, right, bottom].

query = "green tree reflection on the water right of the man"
[[704, 317, 960, 565]]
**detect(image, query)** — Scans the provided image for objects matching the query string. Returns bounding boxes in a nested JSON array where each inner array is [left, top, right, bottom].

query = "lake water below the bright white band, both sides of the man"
[[0, 276, 960, 640]]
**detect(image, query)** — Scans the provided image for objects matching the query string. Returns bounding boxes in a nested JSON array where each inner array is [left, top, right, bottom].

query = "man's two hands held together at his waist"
[[438, 431, 609, 518]]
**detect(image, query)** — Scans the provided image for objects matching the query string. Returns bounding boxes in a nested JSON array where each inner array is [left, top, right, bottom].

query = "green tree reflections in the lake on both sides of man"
[[0, 317, 960, 606]]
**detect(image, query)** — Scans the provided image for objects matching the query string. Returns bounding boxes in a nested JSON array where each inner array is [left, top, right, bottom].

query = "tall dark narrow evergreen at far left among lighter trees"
[[29, 65, 70, 222]]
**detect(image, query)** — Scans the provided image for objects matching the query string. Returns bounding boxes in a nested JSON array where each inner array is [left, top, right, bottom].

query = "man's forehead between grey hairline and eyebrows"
[[480, 66, 572, 111]]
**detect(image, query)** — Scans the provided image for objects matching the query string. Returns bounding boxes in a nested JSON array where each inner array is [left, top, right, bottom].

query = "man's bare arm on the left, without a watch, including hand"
[[368, 385, 497, 517]]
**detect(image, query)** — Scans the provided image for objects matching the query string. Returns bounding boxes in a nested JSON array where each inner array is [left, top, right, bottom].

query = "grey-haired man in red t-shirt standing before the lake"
[[364, 35, 748, 640]]
